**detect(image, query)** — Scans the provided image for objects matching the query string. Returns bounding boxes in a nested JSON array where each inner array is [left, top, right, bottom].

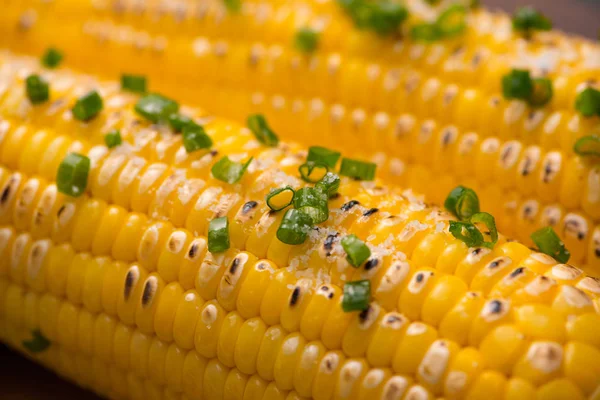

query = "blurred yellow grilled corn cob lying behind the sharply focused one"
[[0, 0, 600, 269]]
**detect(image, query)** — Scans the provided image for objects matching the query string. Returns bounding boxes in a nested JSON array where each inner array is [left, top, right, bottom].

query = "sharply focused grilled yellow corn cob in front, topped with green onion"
[[0, 54, 600, 400]]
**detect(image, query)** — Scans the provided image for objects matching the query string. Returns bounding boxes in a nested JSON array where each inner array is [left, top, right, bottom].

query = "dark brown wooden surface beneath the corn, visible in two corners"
[[0, 0, 600, 400]]
